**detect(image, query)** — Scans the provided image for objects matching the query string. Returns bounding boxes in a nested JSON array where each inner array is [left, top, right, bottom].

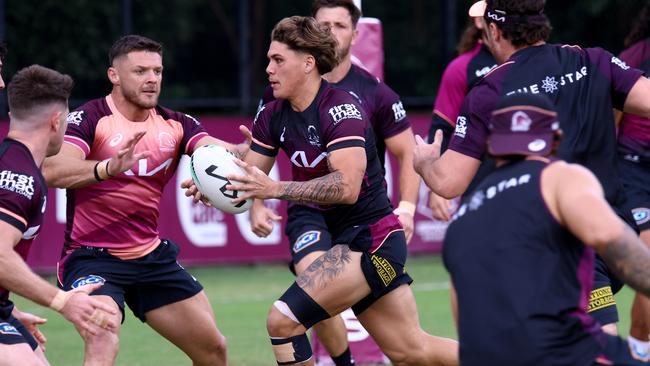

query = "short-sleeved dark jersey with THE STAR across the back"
[[449, 44, 642, 220]]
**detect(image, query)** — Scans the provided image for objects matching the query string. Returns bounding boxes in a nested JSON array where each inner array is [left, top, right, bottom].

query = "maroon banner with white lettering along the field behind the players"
[[0, 115, 446, 271]]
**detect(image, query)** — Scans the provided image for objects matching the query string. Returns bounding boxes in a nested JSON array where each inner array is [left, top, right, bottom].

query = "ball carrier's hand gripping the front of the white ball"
[[226, 160, 280, 204]]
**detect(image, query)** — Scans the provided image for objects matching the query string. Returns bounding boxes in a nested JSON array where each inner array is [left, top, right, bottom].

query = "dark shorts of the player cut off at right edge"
[[618, 158, 650, 231]]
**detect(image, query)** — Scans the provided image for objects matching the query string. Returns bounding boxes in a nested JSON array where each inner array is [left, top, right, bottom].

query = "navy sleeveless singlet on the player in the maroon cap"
[[443, 160, 601, 366]]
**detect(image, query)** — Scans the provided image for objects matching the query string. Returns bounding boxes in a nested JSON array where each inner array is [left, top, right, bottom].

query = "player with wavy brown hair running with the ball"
[[228, 16, 458, 365]]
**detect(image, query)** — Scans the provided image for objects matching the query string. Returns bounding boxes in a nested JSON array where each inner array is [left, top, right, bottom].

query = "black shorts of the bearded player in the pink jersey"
[[59, 240, 203, 322]]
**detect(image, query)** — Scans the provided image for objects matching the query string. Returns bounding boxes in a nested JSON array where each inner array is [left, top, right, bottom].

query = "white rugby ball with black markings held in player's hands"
[[190, 145, 253, 214]]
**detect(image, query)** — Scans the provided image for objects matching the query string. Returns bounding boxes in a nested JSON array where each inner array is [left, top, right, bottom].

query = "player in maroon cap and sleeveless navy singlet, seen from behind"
[[443, 94, 650, 366]]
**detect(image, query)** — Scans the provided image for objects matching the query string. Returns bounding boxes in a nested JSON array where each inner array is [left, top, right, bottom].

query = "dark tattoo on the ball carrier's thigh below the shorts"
[[296, 244, 352, 289]]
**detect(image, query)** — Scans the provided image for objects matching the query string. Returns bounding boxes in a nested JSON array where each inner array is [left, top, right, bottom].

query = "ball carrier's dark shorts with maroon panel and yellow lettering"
[[332, 213, 413, 315]]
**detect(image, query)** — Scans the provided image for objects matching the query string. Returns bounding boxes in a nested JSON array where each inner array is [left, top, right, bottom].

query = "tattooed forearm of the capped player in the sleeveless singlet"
[[600, 225, 650, 296]]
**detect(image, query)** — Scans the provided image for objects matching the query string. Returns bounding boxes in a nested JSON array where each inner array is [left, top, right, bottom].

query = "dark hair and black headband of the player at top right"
[[484, 0, 553, 47]]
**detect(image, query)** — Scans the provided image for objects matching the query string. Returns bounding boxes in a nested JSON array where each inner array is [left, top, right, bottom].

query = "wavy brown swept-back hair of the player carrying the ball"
[[271, 16, 339, 75]]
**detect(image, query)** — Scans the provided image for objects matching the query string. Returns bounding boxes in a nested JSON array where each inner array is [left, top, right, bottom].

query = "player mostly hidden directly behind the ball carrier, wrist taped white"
[[251, 0, 420, 366]]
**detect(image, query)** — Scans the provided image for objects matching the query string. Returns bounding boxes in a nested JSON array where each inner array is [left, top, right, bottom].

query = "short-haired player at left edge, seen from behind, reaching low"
[[0, 66, 118, 366]]
